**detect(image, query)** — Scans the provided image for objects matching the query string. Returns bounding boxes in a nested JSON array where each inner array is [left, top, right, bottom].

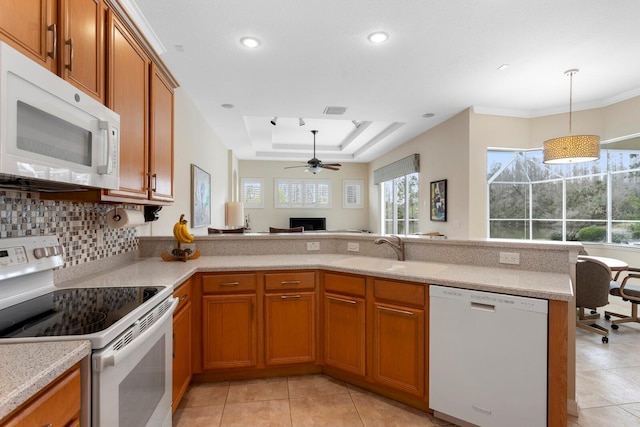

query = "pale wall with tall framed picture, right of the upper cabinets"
[[138, 88, 232, 236]]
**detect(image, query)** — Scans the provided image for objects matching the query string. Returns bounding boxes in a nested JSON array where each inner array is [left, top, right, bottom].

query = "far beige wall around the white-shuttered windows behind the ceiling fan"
[[238, 160, 369, 232]]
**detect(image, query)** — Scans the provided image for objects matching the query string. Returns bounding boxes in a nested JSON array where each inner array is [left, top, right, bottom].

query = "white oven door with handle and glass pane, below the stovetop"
[[91, 299, 178, 427]]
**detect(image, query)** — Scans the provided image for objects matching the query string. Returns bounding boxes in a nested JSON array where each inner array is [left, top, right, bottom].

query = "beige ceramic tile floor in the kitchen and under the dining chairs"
[[173, 297, 640, 427]]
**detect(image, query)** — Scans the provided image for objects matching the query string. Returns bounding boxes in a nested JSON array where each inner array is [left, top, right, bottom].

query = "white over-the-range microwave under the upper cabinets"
[[0, 42, 120, 191]]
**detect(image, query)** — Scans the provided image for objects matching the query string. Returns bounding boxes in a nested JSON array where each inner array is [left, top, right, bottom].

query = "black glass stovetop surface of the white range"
[[0, 287, 161, 338]]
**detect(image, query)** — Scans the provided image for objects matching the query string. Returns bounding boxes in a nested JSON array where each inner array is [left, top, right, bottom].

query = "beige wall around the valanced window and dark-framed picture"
[[369, 110, 469, 239]]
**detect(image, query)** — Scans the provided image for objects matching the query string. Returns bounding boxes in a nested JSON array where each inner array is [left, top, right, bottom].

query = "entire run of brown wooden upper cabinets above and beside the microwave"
[[7, 0, 177, 205]]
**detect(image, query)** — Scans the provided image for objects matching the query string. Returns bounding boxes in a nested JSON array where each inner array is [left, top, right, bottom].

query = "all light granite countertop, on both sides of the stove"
[[0, 254, 572, 417]]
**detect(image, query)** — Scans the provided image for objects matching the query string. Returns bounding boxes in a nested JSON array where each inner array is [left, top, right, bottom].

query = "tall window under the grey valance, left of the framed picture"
[[381, 173, 419, 234]]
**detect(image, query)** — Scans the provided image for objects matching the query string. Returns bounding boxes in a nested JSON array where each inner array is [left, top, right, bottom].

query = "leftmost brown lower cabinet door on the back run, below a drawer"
[[202, 294, 257, 369]]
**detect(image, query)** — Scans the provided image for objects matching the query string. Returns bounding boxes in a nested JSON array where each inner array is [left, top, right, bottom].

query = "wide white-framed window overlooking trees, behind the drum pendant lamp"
[[487, 144, 640, 245]]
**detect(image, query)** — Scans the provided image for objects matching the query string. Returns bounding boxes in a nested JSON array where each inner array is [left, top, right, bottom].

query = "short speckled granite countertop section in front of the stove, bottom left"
[[0, 340, 91, 419]]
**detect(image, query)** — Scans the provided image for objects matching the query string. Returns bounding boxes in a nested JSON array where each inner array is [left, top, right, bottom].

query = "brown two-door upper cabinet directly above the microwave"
[[0, 0, 105, 102]]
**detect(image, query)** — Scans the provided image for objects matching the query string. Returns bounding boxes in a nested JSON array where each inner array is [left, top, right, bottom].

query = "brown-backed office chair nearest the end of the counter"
[[576, 259, 611, 344]]
